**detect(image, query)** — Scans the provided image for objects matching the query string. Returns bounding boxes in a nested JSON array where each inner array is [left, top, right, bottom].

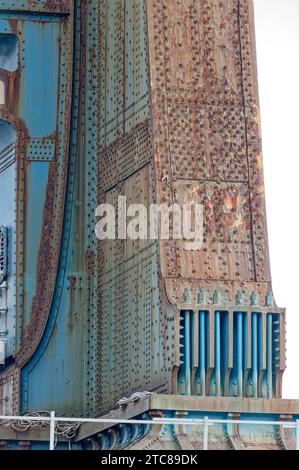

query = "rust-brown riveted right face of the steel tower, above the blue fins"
[[148, 0, 271, 296]]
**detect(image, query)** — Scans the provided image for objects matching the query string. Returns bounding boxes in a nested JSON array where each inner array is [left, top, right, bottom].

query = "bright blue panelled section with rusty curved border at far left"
[[0, 2, 72, 409]]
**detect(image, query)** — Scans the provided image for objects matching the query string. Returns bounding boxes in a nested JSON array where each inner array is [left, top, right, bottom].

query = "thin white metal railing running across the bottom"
[[0, 411, 299, 450]]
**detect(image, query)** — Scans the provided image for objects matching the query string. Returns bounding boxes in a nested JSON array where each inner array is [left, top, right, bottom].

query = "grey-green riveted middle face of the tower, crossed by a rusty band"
[[97, 0, 172, 411]]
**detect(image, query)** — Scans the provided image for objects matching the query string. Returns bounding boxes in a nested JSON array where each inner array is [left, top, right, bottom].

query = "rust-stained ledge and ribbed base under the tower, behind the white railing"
[[0, 394, 299, 451]]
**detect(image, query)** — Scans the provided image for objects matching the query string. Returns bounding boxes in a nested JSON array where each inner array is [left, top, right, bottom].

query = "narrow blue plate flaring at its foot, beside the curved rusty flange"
[[21, 2, 80, 414]]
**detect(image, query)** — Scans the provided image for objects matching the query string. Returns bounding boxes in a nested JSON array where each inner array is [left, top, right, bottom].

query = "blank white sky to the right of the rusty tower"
[[254, 0, 299, 399]]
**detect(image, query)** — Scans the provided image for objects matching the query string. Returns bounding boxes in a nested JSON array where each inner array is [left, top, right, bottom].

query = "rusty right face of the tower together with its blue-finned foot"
[[147, 0, 284, 397]]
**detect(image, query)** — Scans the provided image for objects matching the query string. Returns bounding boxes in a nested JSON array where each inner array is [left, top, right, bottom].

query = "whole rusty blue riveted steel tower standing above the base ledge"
[[0, 0, 287, 432]]
